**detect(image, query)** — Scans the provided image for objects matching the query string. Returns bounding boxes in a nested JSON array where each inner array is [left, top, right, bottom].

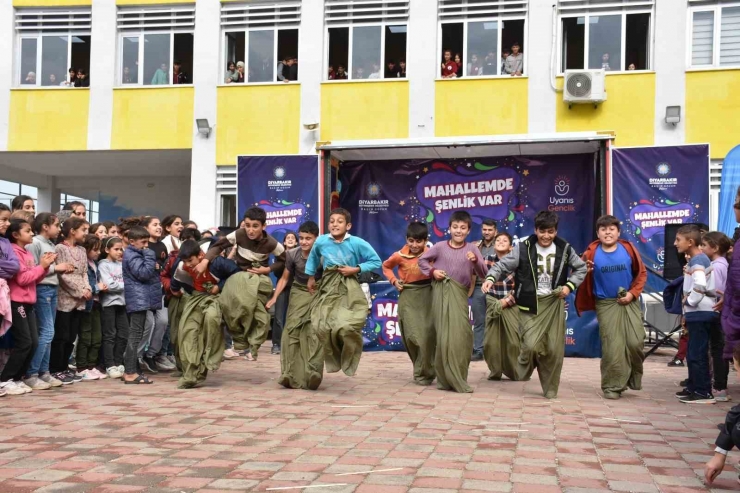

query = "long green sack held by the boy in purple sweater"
[[432, 277, 473, 392]]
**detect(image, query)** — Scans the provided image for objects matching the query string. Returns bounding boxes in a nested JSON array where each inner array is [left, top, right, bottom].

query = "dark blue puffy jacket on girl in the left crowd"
[[123, 245, 162, 313]]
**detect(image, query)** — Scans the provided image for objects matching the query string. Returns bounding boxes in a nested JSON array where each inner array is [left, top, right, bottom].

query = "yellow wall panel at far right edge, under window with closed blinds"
[[681, 70, 740, 159]]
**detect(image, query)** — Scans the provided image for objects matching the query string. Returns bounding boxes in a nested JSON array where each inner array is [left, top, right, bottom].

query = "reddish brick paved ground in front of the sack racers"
[[0, 348, 740, 493]]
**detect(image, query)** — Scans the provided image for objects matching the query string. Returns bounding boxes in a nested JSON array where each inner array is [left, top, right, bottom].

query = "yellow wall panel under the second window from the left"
[[111, 87, 195, 149]]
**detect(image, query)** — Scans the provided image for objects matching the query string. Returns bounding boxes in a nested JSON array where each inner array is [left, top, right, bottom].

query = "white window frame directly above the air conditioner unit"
[[557, 7, 655, 76]]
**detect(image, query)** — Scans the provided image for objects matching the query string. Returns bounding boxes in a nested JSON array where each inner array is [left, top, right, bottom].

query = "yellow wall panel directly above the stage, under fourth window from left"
[[319, 81, 409, 141]]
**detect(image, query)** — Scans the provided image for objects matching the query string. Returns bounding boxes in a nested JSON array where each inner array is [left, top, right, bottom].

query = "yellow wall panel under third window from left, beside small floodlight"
[[216, 84, 301, 165]]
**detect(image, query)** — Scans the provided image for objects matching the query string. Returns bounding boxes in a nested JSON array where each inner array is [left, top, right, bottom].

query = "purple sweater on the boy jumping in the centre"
[[419, 241, 487, 288]]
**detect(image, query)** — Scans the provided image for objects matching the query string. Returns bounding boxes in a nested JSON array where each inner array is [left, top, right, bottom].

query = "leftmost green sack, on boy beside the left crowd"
[[178, 292, 224, 388]]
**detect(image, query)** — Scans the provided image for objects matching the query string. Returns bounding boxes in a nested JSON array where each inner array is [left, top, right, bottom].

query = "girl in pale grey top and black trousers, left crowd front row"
[[98, 236, 128, 378]]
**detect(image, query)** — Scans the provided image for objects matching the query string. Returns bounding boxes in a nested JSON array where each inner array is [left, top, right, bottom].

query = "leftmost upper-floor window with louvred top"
[[15, 9, 92, 87]]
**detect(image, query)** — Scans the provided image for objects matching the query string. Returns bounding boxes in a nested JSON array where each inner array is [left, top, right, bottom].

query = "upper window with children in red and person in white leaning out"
[[438, 0, 528, 78]]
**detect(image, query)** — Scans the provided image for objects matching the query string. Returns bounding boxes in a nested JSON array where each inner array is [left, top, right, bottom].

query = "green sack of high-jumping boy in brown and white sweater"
[[219, 272, 272, 359]]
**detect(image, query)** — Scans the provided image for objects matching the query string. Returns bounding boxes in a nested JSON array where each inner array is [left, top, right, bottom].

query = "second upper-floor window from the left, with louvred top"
[[118, 5, 195, 86]]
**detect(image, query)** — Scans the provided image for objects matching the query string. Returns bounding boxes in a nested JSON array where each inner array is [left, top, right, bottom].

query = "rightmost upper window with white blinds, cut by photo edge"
[[689, 2, 740, 67]]
